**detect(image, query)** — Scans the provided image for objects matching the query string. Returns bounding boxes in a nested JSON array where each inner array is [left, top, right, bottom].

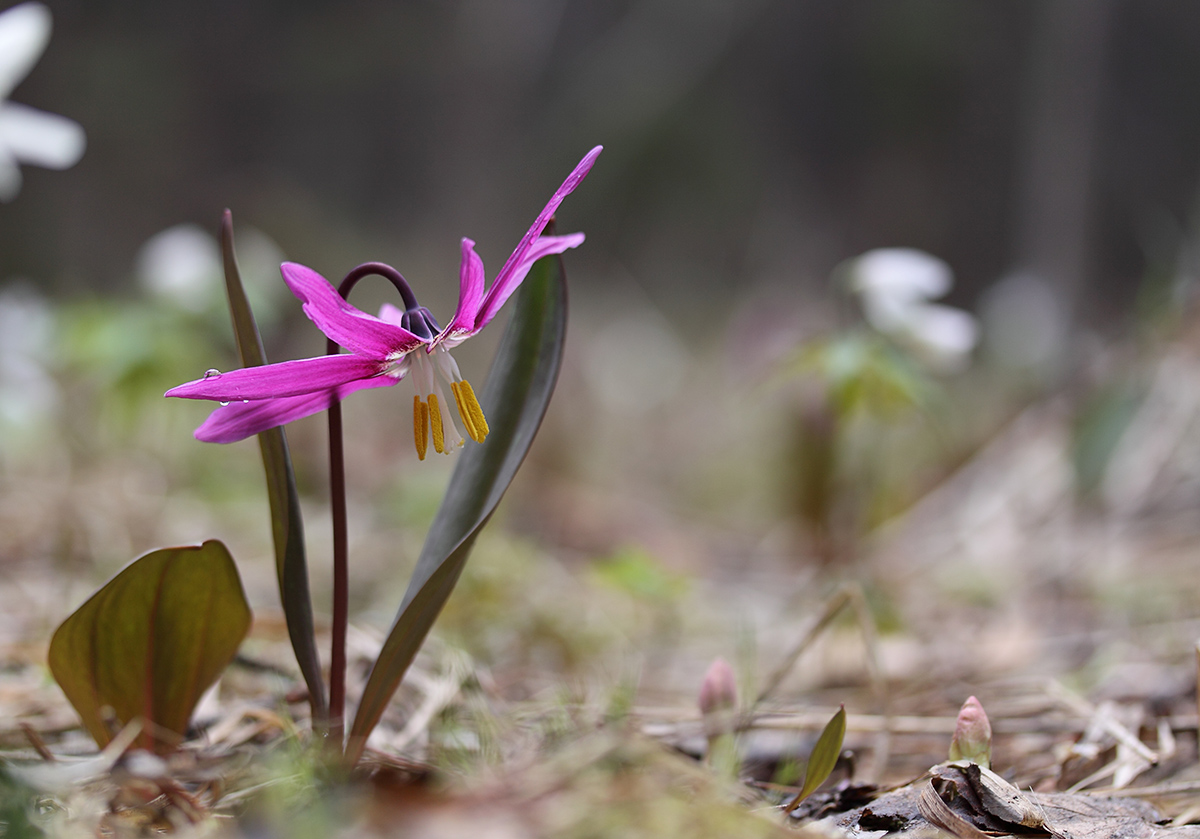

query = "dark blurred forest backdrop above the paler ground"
[[14, 0, 1200, 325]]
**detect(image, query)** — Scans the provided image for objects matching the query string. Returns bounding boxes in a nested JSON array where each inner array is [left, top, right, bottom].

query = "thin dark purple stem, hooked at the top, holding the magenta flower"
[[325, 262, 416, 754]]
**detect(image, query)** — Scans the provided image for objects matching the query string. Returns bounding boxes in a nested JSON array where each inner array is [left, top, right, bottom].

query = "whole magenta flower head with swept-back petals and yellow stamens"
[[166, 145, 602, 460]]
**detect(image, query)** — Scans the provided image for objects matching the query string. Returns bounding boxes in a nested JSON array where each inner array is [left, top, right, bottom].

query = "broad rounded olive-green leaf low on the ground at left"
[[49, 540, 250, 751]]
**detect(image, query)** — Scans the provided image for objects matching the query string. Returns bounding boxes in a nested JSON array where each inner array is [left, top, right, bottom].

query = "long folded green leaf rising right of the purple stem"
[[347, 247, 566, 763]]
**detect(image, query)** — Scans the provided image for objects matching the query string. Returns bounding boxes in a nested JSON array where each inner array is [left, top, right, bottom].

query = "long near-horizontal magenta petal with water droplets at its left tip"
[[164, 354, 384, 402]]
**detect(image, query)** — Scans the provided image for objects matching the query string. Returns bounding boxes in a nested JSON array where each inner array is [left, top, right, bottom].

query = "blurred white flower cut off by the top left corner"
[[0, 2, 88, 202]]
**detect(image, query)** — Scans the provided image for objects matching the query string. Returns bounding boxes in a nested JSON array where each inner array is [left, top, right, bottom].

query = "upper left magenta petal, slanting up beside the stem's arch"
[[280, 262, 424, 358]]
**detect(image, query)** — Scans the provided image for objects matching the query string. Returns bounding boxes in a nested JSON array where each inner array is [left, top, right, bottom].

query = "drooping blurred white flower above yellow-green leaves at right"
[[851, 247, 979, 372]]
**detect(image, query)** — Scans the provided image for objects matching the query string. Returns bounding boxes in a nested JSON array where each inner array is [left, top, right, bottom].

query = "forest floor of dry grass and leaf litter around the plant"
[[7, 321, 1200, 839]]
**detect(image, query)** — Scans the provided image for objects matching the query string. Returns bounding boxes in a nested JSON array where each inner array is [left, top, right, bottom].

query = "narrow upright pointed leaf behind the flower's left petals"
[[221, 210, 328, 720]]
